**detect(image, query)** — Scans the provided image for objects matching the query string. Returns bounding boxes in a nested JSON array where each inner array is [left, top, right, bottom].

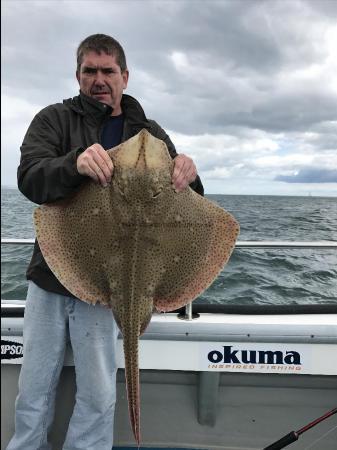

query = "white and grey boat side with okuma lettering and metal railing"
[[1, 239, 337, 450]]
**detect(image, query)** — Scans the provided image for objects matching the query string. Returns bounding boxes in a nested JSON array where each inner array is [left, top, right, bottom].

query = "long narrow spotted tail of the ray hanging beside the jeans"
[[123, 332, 140, 448]]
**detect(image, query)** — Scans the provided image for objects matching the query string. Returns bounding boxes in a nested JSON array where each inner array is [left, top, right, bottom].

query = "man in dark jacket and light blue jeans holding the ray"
[[7, 34, 203, 450]]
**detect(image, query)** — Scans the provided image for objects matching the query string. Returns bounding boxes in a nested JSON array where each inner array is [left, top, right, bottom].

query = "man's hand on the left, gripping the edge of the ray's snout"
[[77, 144, 114, 187]]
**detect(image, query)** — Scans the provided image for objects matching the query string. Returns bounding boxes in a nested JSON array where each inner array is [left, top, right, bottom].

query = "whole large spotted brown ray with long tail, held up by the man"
[[34, 129, 240, 447]]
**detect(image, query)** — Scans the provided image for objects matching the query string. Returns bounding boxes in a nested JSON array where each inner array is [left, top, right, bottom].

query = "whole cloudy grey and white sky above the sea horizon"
[[1, 0, 337, 196]]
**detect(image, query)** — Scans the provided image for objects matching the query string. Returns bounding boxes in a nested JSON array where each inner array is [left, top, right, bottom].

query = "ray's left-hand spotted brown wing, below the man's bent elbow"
[[34, 174, 124, 306]]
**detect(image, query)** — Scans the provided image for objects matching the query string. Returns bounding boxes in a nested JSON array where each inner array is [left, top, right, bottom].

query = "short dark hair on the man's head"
[[76, 34, 127, 72]]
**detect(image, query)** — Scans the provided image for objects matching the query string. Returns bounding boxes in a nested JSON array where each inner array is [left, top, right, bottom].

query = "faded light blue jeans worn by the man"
[[7, 281, 118, 450]]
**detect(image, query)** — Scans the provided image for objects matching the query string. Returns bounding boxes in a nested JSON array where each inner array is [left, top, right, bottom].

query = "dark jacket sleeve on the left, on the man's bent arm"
[[17, 108, 87, 204]]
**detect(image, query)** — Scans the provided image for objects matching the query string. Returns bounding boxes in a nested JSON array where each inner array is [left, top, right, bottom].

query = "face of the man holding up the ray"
[[76, 51, 129, 116]]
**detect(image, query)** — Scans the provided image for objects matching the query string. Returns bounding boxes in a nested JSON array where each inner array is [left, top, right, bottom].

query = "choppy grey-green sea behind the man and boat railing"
[[1, 187, 337, 305]]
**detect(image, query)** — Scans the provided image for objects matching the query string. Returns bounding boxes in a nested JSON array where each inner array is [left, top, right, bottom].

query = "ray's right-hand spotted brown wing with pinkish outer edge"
[[148, 188, 239, 311]]
